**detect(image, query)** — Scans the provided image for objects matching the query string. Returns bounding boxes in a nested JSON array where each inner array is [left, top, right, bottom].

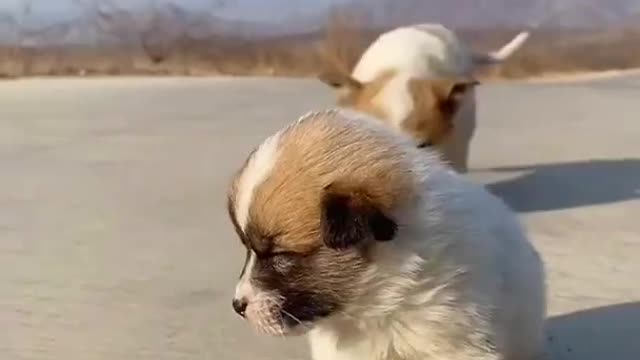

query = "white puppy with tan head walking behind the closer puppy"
[[319, 24, 529, 172]]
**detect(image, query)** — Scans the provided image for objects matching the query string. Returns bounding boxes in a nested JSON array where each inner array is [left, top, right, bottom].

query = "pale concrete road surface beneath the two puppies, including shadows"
[[0, 74, 640, 360]]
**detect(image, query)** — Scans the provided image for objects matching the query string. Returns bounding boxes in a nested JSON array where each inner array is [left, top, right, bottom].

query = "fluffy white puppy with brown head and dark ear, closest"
[[228, 109, 546, 360]]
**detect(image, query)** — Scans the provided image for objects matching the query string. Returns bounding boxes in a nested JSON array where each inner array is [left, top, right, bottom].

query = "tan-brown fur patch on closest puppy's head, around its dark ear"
[[244, 111, 414, 253]]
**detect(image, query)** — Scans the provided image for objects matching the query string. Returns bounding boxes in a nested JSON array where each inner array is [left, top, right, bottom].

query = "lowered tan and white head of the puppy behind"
[[319, 70, 478, 147]]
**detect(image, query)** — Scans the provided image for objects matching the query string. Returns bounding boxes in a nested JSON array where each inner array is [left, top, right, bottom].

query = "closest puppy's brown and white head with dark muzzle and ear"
[[228, 111, 417, 335]]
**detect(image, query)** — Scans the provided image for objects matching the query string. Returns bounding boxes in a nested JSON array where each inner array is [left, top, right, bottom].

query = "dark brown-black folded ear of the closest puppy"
[[321, 184, 398, 249]]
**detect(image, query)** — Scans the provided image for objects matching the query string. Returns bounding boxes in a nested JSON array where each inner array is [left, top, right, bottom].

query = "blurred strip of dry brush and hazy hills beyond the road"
[[0, 0, 640, 78]]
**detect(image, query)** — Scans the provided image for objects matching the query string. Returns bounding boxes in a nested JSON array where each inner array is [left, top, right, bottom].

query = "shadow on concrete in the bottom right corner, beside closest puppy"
[[547, 302, 640, 360]]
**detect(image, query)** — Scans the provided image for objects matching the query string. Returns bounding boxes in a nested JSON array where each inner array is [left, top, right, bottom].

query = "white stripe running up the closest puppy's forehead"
[[236, 132, 280, 230]]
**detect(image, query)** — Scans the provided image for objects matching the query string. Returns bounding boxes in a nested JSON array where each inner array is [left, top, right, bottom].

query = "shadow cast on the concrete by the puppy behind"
[[487, 159, 640, 212]]
